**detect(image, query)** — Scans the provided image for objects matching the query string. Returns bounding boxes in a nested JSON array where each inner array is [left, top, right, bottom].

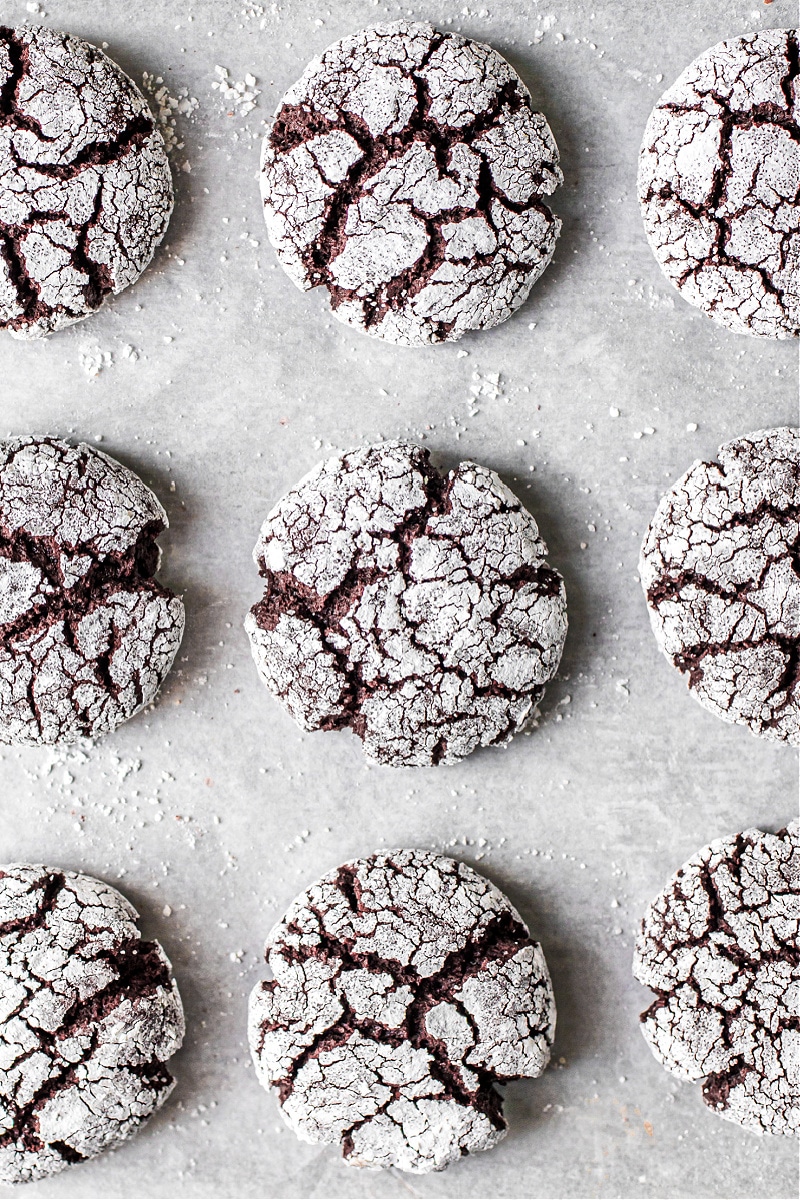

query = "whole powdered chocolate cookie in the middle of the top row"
[[261, 20, 564, 346]]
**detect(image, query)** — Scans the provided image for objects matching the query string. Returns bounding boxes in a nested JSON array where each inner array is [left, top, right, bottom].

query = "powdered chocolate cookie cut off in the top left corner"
[[0, 26, 173, 337]]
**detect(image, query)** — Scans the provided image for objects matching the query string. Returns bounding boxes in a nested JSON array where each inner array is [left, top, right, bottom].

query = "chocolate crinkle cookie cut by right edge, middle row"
[[639, 428, 800, 745]]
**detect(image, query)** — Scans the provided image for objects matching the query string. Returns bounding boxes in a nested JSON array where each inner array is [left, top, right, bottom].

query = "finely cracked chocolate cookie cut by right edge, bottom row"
[[633, 821, 800, 1135]]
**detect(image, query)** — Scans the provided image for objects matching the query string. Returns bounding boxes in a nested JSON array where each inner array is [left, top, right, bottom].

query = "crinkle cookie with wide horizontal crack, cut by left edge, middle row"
[[0, 438, 184, 743]]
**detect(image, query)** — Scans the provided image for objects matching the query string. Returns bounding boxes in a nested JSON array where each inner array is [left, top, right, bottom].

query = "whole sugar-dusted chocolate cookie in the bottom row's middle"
[[249, 850, 555, 1172]]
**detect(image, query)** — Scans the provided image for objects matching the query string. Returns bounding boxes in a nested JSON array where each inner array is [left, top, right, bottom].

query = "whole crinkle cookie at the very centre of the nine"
[[246, 442, 566, 767]]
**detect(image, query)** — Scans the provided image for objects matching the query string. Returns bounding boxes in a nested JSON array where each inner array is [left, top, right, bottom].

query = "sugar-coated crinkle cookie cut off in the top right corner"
[[638, 29, 800, 337]]
